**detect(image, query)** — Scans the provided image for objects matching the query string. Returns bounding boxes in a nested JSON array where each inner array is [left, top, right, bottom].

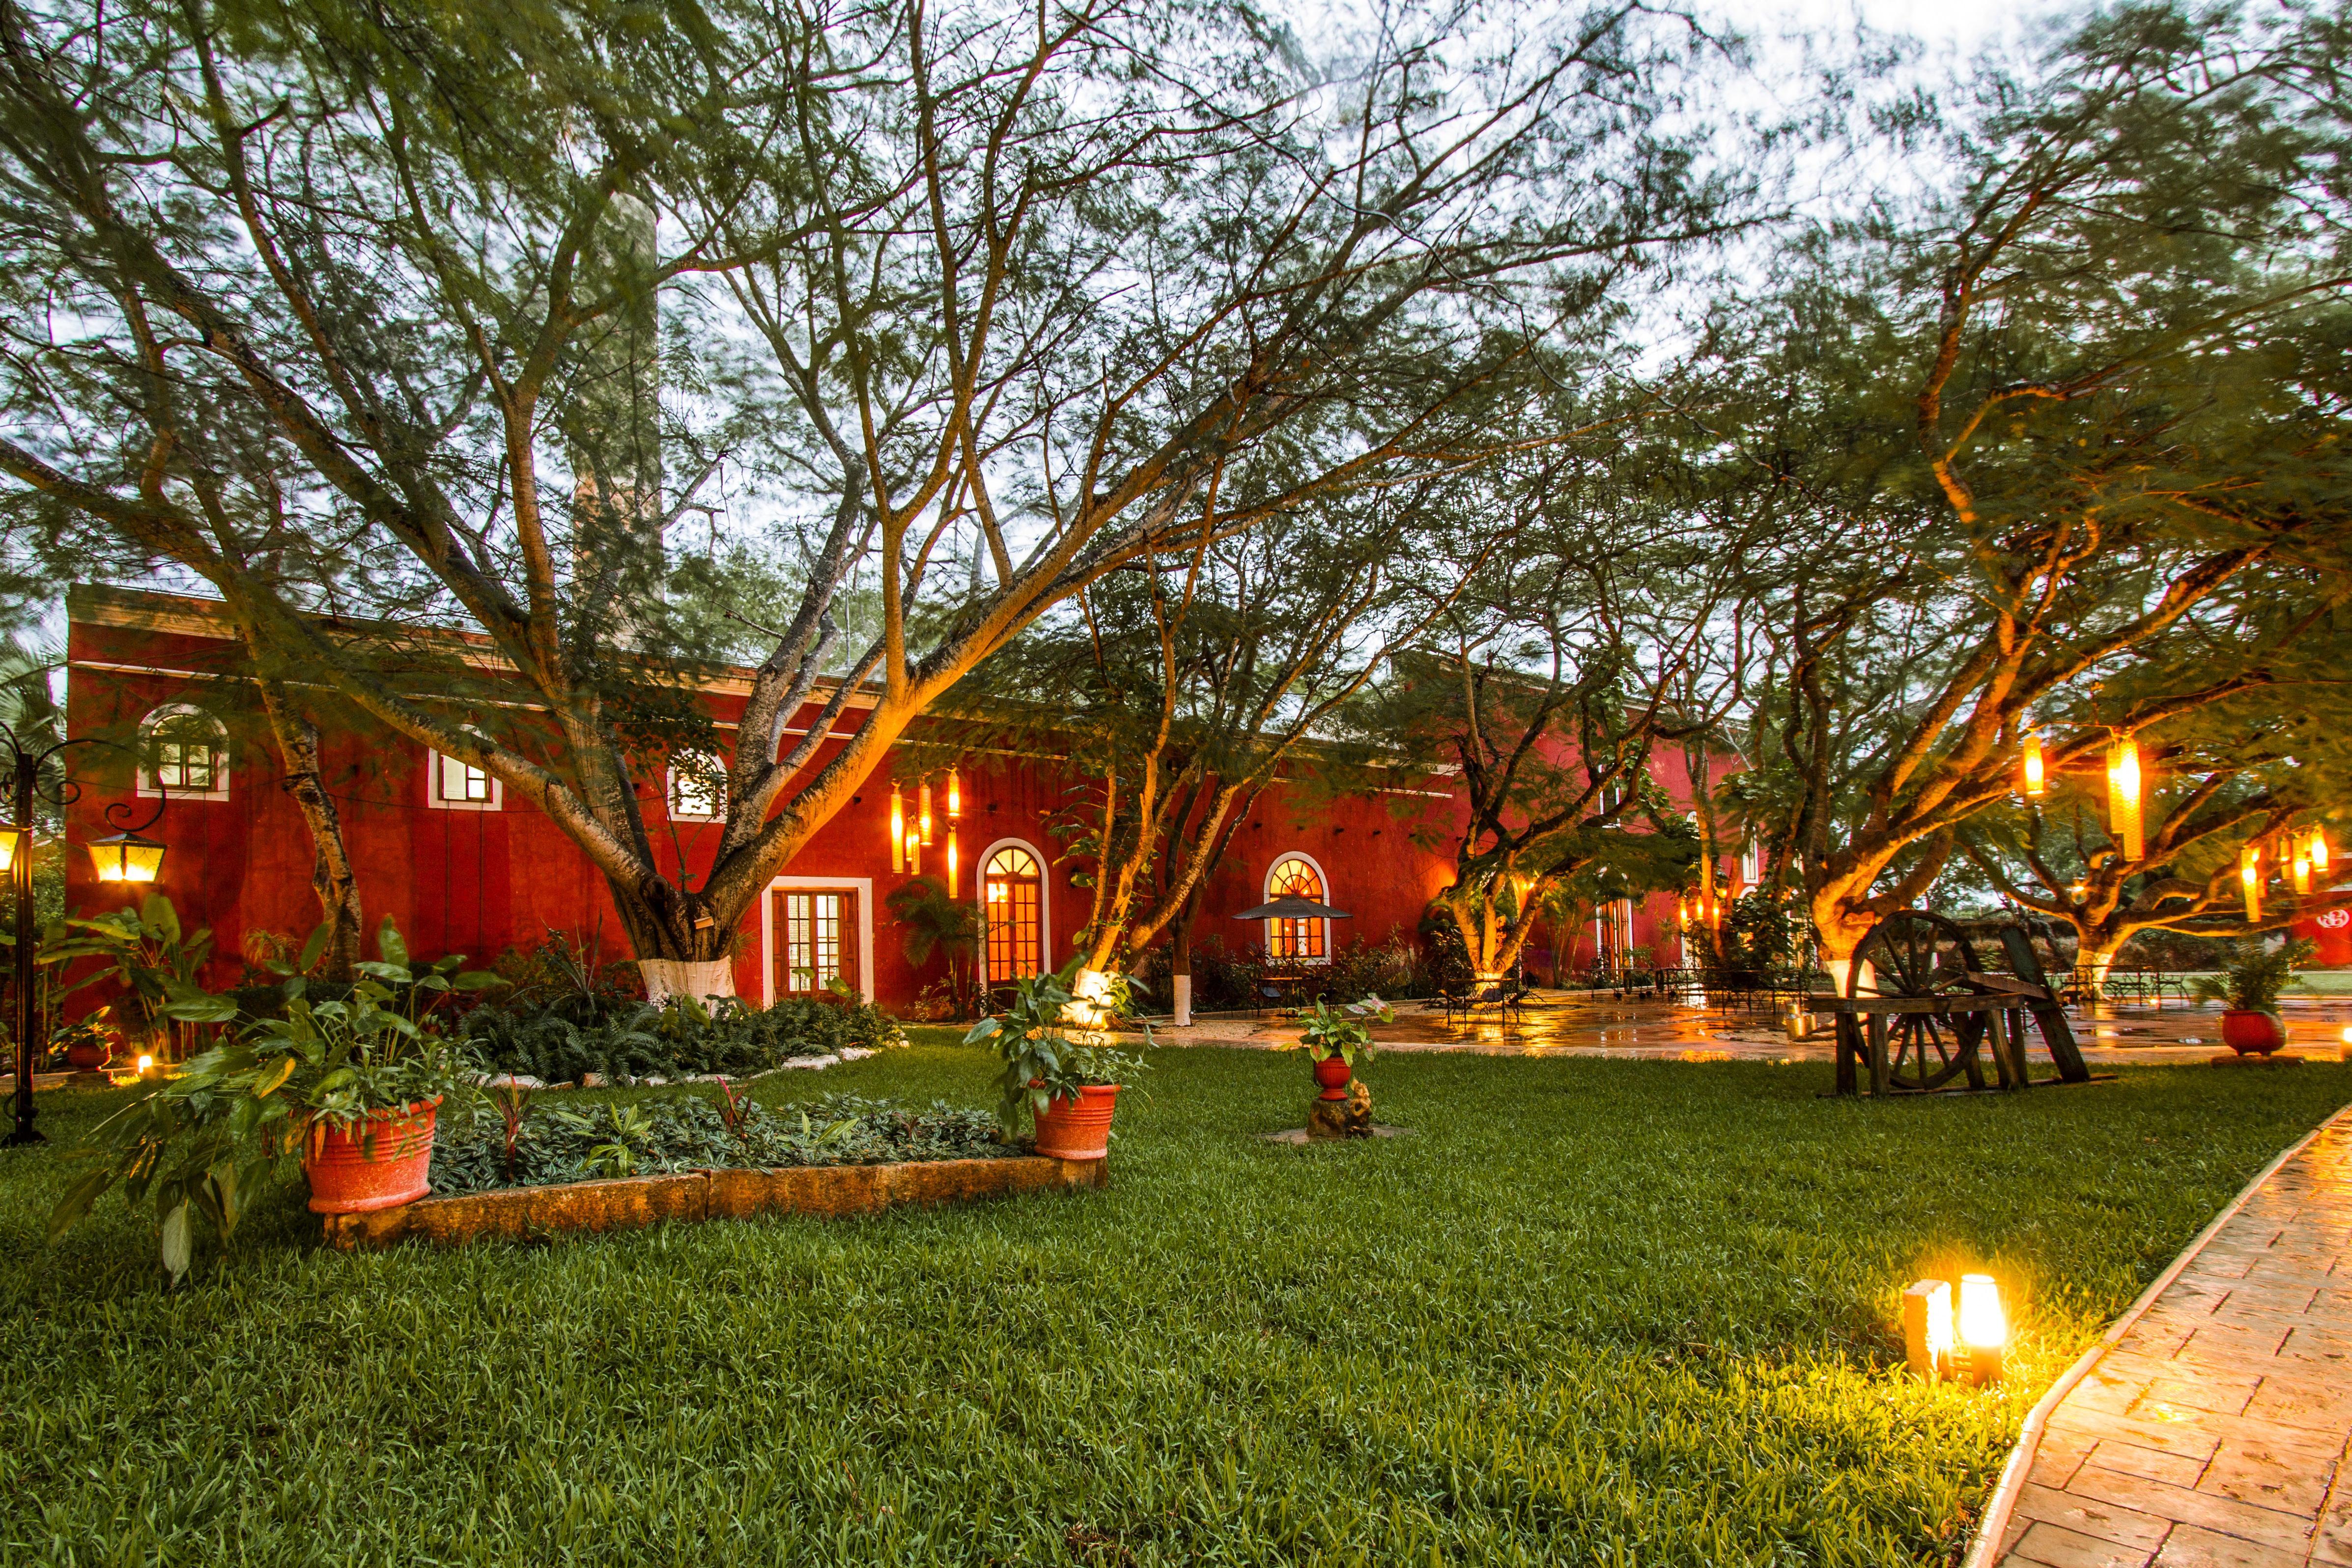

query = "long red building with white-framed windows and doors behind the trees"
[[66, 588, 1722, 1006]]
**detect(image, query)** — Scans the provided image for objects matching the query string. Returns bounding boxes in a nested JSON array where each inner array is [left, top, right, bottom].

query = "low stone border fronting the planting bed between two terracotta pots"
[[327, 1154, 1110, 1253]]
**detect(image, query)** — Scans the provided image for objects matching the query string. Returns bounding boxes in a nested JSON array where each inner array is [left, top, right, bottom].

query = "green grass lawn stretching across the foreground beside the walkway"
[[0, 1032, 2352, 1566]]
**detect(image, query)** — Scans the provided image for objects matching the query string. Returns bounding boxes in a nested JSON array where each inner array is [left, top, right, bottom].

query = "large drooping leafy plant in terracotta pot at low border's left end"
[[50, 919, 506, 1281]]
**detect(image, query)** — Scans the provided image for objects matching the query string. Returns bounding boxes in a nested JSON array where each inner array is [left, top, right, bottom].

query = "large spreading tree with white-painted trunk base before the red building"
[[0, 0, 1729, 990]]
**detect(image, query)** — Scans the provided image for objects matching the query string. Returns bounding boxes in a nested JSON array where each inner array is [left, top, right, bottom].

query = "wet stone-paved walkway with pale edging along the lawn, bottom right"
[[2002, 1114, 2352, 1568]]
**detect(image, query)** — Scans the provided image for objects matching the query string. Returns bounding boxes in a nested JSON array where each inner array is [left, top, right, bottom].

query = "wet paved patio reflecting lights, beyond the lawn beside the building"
[[1153, 992, 2352, 1067]]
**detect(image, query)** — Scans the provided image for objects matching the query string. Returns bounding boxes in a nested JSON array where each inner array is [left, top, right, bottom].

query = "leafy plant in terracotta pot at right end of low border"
[[964, 964, 1153, 1159]]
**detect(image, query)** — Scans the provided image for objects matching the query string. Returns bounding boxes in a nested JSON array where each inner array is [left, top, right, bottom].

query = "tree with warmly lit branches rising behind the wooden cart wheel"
[[1719, 5, 2352, 976]]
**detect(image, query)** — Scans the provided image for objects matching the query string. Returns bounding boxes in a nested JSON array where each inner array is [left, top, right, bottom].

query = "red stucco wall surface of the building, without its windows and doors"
[[66, 595, 1731, 1006]]
